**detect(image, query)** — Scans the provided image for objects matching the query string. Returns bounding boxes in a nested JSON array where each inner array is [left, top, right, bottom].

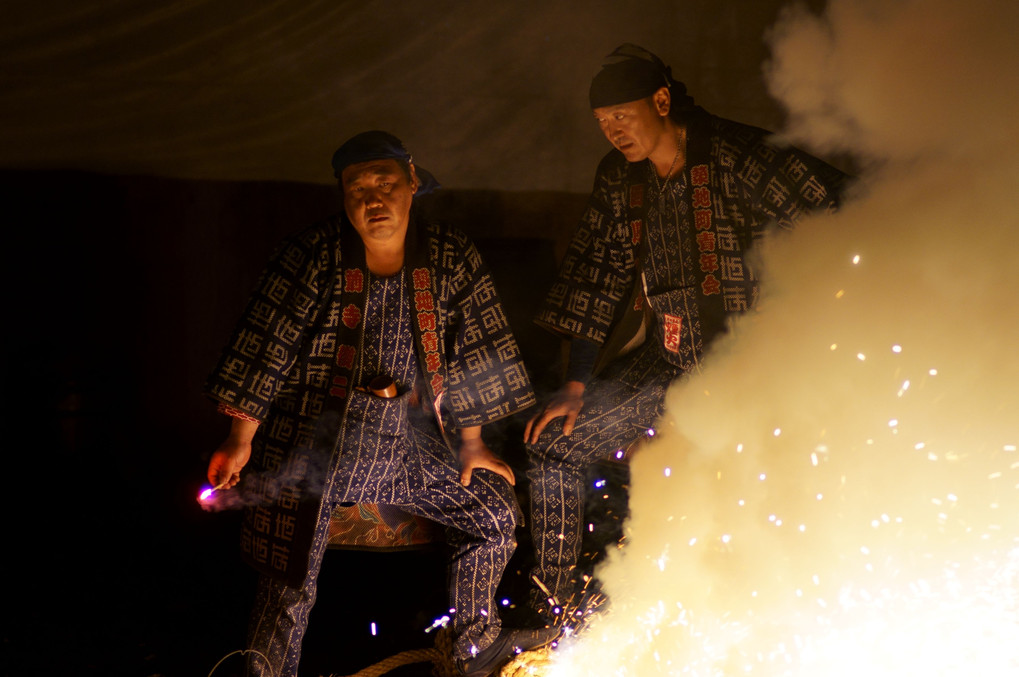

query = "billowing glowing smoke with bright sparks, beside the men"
[[552, 0, 1019, 677]]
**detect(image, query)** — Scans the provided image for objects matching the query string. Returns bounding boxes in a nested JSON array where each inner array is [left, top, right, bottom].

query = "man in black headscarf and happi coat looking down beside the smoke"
[[525, 44, 846, 613]]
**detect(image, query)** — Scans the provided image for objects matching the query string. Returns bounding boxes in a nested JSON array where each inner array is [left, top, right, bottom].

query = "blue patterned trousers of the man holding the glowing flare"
[[248, 393, 521, 677]]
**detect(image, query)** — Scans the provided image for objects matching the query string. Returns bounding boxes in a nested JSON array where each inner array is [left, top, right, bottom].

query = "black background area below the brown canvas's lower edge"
[[0, 171, 635, 676]]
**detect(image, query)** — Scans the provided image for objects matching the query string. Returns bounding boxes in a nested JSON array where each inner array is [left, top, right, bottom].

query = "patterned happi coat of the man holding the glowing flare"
[[206, 211, 534, 585]]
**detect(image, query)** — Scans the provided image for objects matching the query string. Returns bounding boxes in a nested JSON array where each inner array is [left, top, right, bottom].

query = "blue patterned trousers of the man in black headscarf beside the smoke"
[[527, 342, 681, 616]]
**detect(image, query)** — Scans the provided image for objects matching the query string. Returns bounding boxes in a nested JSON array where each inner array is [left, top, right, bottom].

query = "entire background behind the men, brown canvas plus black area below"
[[0, 0, 821, 677]]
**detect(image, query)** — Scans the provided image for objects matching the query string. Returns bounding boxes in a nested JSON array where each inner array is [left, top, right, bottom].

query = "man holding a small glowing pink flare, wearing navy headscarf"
[[206, 132, 551, 677]]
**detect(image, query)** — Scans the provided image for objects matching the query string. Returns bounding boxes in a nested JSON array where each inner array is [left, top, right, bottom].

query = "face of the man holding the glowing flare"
[[340, 159, 418, 244]]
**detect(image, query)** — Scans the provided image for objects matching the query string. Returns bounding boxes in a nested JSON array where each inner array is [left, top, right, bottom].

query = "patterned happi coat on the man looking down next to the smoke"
[[536, 114, 846, 372]]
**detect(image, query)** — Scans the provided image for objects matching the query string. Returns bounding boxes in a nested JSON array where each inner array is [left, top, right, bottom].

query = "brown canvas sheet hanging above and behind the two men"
[[0, 0, 811, 192]]
